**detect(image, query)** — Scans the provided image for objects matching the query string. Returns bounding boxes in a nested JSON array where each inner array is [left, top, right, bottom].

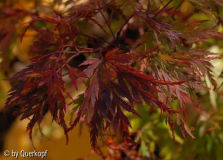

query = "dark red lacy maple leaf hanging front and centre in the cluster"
[[67, 49, 184, 149]]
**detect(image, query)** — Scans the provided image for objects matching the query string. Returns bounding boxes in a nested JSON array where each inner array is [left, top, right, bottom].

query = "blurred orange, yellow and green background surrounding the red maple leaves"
[[0, 0, 223, 160]]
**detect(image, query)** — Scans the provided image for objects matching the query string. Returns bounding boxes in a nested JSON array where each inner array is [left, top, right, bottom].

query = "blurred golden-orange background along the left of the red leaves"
[[0, 0, 100, 160]]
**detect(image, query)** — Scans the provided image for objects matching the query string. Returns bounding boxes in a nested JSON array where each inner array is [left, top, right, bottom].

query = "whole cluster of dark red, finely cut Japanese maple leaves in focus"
[[3, 0, 223, 151]]
